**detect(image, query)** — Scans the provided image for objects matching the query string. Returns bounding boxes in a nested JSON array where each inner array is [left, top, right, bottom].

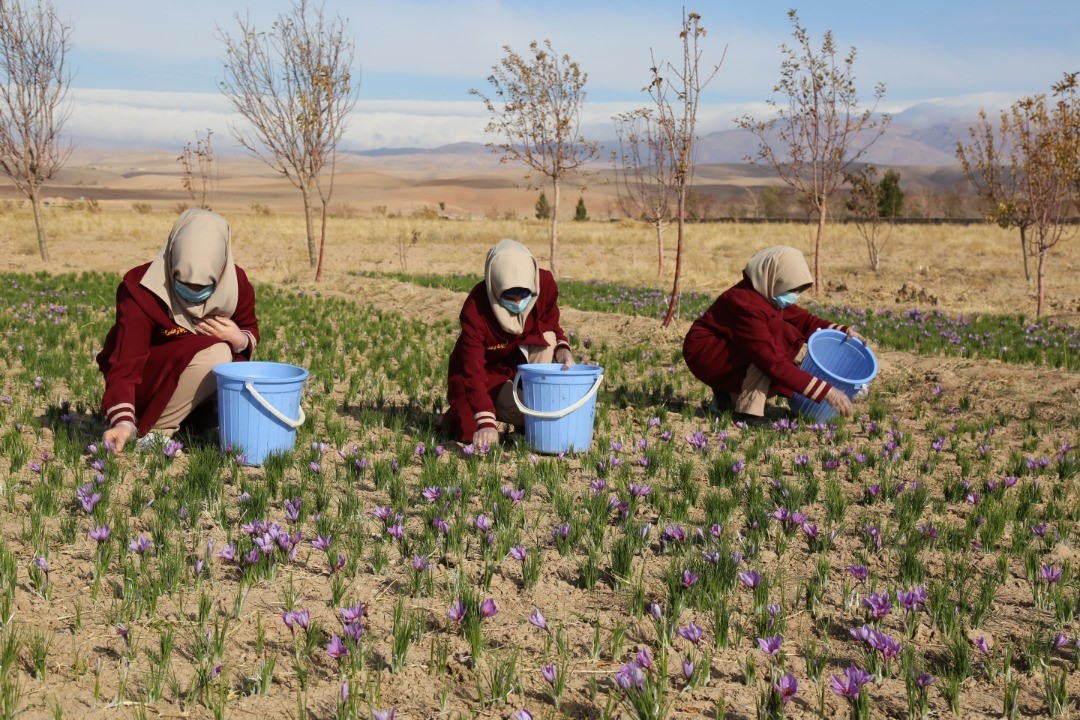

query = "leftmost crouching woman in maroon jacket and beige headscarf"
[[97, 209, 259, 452]]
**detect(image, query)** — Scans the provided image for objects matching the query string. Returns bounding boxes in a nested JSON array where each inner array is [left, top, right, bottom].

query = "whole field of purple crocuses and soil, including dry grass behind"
[[0, 203, 1080, 718]]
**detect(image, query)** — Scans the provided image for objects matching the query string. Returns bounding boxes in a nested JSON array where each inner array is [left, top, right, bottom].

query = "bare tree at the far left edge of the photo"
[[0, 0, 71, 261]]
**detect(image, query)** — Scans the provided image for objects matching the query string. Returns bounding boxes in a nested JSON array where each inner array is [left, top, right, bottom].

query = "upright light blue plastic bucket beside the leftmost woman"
[[214, 362, 308, 465]]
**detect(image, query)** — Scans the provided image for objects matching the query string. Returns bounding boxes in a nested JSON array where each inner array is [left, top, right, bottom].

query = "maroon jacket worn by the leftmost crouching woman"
[[97, 262, 259, 435]]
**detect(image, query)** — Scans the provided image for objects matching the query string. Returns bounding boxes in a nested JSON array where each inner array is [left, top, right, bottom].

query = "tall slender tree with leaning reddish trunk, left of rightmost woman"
[[646, 11, 727, 327]]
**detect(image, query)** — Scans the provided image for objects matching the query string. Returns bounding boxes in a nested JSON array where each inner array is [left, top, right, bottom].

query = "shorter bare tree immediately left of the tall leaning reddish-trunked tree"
[[611, 108, 675, 277]]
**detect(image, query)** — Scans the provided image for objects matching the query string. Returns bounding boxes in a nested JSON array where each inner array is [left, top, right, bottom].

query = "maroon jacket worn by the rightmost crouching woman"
[[683, 277, 848, 403]]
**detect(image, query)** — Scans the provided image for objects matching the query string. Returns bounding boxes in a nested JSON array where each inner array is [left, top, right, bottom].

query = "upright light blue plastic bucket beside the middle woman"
[[514, 363, 604, 454]]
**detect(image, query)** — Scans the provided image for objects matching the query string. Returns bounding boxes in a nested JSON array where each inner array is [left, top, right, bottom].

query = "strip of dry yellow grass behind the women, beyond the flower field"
[[0, 206, 1080, 315]]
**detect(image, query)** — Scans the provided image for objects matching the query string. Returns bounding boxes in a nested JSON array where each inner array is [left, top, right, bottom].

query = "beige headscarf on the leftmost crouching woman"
[[139, 209, 240, 330]]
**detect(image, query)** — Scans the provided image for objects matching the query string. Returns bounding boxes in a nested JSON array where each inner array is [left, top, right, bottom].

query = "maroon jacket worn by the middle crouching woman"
[[443, 270, 570, 443]]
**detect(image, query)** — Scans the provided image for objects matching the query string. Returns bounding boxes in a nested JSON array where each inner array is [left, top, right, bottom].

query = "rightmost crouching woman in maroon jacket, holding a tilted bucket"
[[683, 245, 863, 420]]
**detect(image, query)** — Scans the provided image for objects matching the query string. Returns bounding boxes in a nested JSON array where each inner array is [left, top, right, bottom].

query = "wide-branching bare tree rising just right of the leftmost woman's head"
[[217, 0, 357, 280]]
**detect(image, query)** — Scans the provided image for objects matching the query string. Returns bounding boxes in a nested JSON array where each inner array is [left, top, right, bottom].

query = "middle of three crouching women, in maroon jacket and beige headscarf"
[[443, 240, 573, 447]]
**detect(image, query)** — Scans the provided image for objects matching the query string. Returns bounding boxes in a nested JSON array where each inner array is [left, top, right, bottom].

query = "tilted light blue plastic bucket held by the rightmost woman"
[[792, 329, 878, 422]]
